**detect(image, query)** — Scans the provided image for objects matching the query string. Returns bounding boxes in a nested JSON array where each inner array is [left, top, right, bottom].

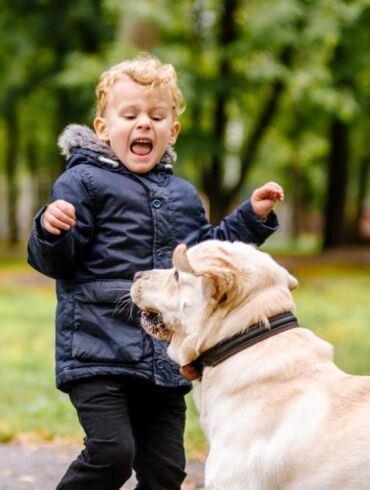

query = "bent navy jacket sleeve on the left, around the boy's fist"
[[28, 171, 94, 279]]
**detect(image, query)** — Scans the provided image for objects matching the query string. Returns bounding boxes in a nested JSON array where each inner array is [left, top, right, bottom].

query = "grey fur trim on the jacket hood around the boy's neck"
[[58, 124, 177, 166]]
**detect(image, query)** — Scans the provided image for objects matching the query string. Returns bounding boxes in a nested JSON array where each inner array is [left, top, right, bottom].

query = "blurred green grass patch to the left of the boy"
[[0, 286, 81, 441]]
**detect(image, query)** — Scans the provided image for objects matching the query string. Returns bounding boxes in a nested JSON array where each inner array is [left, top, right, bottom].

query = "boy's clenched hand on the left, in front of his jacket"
[[41, 199, 76, 235]]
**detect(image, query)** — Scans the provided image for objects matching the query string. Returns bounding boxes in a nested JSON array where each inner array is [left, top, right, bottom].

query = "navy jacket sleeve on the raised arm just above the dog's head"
[[199, 195, 279, 245]]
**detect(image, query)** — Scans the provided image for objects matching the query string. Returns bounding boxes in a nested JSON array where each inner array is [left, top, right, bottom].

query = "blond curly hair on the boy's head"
[[95, 53, 185, 117]]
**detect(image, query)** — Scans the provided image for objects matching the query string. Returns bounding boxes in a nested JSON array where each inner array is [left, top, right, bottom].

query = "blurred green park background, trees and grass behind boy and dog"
[[0, 0, 370, 468]]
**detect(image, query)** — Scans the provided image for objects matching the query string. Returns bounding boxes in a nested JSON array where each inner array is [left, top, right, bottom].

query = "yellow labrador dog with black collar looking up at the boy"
[[131, 241, 370, 490]]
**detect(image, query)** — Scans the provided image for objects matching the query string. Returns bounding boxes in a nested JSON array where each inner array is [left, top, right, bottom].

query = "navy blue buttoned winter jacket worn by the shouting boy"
[[28, 125, 278, 390]]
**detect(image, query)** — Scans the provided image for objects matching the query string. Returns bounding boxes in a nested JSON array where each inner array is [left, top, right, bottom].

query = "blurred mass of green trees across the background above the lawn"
[[0, 0, 370, 246]]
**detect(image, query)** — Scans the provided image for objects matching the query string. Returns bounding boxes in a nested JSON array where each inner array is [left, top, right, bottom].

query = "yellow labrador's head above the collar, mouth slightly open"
[[131, 240, 298, 364]]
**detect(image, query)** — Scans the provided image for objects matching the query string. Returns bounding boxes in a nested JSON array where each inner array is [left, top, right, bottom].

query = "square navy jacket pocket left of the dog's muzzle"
[[72, 280, 144, 363]]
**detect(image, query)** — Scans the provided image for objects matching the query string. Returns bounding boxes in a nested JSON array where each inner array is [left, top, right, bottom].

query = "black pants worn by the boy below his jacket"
[[57, 376, 186, 490]]
